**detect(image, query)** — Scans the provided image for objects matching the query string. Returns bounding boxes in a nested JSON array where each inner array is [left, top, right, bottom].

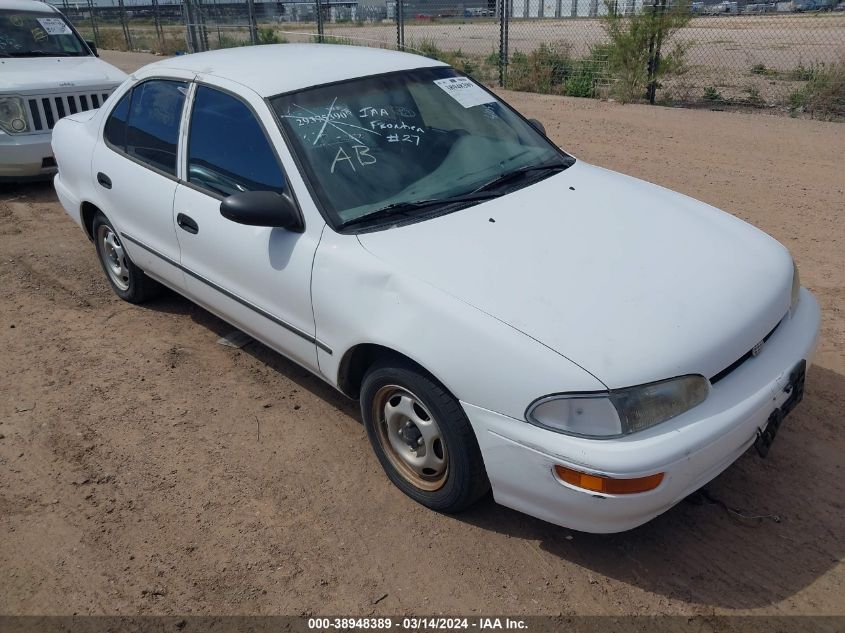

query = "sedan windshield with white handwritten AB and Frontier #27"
[[270, 68, 574, 227]]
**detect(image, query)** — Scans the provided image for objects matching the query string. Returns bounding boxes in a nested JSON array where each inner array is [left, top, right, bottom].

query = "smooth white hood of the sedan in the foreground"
[[359, 161, 792, 389]]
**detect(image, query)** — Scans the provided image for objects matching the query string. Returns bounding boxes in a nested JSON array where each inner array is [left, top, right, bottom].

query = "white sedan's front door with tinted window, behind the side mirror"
[[173, 84, 325, 371]]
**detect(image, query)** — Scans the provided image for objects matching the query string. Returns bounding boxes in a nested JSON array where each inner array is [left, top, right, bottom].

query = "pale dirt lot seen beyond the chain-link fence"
[[90, 13, 845, 74]]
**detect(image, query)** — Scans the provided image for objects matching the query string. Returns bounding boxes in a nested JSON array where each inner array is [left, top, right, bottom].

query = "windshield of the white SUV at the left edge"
[[0, 9, 90, 57]]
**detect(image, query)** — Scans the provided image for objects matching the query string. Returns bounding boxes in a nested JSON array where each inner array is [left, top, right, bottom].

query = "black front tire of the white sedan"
[[361, 358, 490, 513]]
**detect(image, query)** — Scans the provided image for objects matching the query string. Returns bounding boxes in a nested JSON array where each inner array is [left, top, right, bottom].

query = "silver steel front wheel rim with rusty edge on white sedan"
[[372, 385, 449, 492]]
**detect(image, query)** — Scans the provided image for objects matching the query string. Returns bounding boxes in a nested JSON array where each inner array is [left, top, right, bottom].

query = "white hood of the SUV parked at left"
[[0, 56, 126, 94]]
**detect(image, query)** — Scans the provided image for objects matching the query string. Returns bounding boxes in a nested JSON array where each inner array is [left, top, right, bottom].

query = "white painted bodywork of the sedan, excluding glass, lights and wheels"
[[54, 45, 820, 532]]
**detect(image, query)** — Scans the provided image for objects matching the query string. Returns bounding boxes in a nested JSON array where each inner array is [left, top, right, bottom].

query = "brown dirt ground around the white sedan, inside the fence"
[[0, 50, 845, 615]]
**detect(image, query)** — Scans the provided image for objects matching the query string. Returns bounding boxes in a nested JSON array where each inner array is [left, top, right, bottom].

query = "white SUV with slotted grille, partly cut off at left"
[[0, 0, 126, 182]]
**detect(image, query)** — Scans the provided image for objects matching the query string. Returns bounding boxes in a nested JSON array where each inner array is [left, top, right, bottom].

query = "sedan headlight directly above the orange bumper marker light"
[[526, 375, 710, 438]]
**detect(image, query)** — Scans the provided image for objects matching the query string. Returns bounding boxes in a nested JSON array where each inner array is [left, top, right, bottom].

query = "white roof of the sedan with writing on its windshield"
[[143, 44, 447, 97]]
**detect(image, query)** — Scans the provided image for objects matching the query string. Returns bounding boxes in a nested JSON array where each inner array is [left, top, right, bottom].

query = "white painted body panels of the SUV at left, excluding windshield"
[[0, 0, 126, 181]]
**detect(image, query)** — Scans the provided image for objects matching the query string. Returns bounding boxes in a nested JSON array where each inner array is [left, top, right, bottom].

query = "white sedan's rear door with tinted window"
[[92, 79, 188, 289]]
